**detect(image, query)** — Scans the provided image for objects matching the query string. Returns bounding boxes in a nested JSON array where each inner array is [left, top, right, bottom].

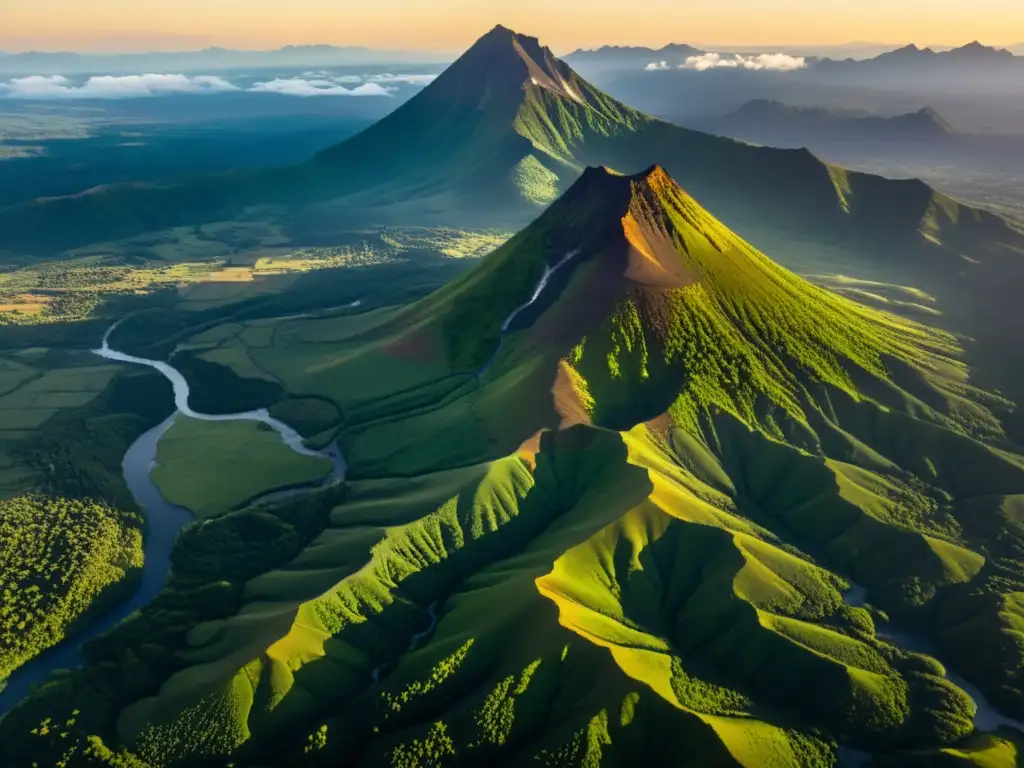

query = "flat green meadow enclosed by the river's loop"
[[151, 416, 332, 519]]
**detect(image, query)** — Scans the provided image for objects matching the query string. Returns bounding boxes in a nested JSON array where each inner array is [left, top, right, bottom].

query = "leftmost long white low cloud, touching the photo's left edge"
[[0, 75, 239, 99]]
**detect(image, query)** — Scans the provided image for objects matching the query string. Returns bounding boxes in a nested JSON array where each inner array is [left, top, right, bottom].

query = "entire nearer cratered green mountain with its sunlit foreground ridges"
[[0, 168, 1024, 768]]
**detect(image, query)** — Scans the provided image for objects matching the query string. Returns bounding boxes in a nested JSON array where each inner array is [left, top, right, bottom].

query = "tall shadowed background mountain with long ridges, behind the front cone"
[[0, 27, 1024, 264]]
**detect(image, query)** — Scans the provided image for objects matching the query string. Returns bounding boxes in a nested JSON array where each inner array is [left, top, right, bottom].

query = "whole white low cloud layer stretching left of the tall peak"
[[0, 71, 436, 100]]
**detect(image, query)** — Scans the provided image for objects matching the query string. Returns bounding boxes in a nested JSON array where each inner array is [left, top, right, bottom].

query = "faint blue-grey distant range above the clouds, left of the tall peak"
[[0, 45, 445, 75]]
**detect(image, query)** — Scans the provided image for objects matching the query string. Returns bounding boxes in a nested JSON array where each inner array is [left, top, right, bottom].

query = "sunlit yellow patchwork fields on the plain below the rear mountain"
[[0, 227, 508, 325]]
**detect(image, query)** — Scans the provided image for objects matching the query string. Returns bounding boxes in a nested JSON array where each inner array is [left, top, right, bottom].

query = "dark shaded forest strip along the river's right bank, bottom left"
[[0, 486, 344, 768]]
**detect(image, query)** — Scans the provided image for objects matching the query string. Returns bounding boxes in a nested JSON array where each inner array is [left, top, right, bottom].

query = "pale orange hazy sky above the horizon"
[[0, 0, 1024, 52]]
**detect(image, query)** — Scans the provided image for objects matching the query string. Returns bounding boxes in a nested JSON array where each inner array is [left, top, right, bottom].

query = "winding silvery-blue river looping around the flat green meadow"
[[0, 324, 346, 717]]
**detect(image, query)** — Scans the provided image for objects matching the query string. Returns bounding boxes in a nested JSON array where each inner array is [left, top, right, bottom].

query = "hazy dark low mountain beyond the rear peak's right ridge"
[[696, 99, 954, 146]]
